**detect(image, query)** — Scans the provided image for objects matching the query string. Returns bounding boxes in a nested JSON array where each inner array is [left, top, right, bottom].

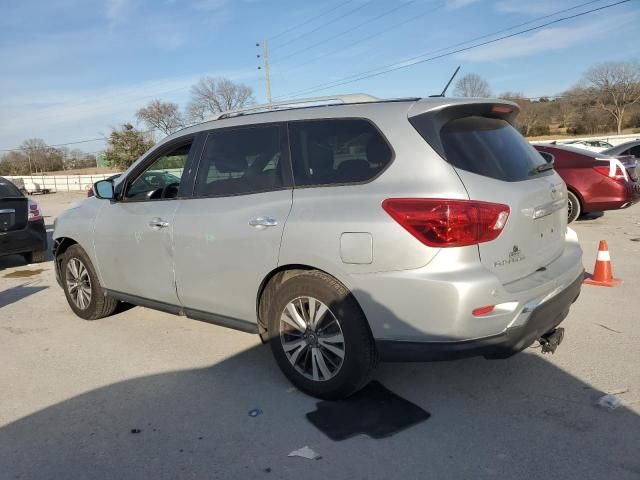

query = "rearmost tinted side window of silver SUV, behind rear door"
[[289, 120, 392, 185]]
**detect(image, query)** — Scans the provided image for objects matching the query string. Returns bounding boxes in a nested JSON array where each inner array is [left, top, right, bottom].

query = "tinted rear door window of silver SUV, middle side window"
[[196, 125, 285, 197]]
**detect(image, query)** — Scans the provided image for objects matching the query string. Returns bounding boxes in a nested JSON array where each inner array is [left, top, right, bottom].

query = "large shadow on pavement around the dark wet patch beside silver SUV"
[[0, 318, 640, 480]]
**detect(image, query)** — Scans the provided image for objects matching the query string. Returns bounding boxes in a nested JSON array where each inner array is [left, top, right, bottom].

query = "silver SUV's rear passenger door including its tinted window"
[[174, 124, 292, 328]]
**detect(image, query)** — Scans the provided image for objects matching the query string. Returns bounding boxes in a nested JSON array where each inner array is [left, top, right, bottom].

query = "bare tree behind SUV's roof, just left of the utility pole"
[[187, 77, 254, 122]]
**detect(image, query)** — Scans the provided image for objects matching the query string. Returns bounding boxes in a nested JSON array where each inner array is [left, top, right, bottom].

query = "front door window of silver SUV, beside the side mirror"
[[125, 143, 191, 201]]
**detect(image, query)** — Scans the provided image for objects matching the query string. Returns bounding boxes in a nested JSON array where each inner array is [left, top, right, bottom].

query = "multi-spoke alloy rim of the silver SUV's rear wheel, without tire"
[[280, 297, 346, 382]]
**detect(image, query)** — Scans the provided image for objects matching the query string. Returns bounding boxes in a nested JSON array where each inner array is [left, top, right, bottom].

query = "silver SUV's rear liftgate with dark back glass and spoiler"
[[410, 103, 567, 283]]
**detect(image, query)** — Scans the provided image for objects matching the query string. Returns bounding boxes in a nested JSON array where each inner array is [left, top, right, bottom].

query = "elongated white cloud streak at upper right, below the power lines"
[[455, 12, 639, 62]]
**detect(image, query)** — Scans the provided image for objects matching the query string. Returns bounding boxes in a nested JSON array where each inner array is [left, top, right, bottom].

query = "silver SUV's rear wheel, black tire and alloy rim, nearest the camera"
[[268, 271, 377, 400]]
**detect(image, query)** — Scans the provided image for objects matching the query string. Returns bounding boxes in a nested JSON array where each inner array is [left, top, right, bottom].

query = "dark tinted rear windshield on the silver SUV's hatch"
[[440, 116, 551, 182]]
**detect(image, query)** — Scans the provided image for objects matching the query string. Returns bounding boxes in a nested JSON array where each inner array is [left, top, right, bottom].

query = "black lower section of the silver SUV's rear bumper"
[[376, 275, 583, 362]]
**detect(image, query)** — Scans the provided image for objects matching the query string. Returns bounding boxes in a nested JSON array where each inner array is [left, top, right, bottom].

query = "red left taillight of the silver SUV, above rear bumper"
[[382, 198, 509, 247]]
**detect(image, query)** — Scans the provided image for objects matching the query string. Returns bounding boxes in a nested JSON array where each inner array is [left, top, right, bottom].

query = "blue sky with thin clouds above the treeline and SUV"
[[0, 0, 640, 153]]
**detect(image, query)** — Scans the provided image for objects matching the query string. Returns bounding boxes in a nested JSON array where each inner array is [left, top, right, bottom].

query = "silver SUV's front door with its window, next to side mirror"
[[94, 137, 193, 305]]
